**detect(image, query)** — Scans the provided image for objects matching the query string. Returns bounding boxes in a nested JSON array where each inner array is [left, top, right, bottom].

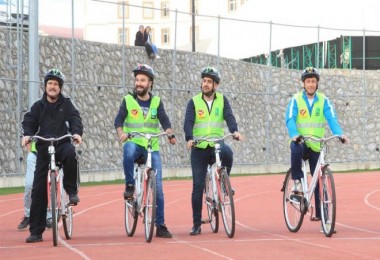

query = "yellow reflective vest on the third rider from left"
[[193, 93, 224, 149]]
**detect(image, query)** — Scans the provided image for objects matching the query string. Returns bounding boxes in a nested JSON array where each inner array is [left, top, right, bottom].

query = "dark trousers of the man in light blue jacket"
[[290, 141, 321, 218]]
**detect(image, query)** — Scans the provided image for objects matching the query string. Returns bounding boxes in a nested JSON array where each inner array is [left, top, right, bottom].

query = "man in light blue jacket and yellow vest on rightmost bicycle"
[[286, 67, 348, 220]]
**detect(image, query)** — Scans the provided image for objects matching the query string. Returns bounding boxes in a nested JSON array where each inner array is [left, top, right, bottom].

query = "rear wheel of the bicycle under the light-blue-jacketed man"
[[283, 170, 304, 232]]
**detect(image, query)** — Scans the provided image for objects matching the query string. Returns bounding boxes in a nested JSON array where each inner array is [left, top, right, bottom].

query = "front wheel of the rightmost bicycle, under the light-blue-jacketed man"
[[319, 167, 336, 237]]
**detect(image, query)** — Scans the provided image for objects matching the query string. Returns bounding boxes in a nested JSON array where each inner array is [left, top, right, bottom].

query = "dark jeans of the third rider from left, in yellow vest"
[[191, 144, 233, 226]]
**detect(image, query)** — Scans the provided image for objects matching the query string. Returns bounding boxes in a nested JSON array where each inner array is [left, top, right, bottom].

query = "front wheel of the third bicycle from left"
[[219, 168, 235, 238]]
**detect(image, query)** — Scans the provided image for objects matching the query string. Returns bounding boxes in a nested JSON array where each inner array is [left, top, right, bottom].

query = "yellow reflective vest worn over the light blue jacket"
[[295, 92, 326, 152]]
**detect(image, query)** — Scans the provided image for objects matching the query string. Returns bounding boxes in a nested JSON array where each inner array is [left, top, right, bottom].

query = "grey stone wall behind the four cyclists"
[[0, 30, 380, 187]]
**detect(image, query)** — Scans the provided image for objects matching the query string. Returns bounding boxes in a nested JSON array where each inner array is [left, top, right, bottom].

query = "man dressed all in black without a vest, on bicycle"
[[22, 69, 83, 243]]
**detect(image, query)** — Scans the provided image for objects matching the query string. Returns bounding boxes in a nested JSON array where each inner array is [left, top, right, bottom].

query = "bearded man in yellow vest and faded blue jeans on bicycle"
[[115, 64, 176, 238]]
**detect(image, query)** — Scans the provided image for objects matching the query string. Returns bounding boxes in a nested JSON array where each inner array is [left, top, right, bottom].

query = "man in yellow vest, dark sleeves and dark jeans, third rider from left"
[[184, 67, 242, 236]]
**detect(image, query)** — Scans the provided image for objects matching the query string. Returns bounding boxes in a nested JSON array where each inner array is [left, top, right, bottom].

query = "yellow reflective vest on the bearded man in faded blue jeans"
[[123, 95, 160, 151]]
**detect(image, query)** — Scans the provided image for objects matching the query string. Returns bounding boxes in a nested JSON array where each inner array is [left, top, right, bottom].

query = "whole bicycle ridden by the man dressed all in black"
[[31, 134, 79, 246]]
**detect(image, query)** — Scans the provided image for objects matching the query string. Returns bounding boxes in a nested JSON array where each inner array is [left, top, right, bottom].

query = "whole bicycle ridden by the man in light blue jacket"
[[281, 135, 344, 237]]
